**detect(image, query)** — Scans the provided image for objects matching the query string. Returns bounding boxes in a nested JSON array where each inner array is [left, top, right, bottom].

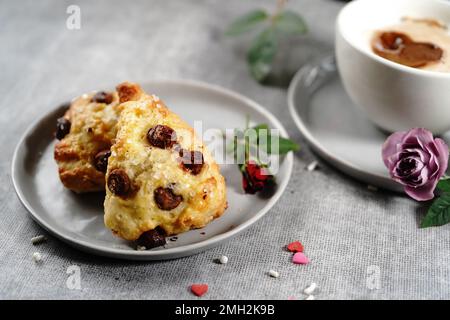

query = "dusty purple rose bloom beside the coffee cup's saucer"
[[382, 128, 449, 201]]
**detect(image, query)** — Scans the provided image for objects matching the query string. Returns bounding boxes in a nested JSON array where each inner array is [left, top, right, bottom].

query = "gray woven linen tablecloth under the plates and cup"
[[0, 0, 450, 299]]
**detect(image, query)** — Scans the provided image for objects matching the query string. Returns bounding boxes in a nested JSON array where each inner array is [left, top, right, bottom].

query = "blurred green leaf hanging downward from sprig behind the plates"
[[247, 28, 277, 81]]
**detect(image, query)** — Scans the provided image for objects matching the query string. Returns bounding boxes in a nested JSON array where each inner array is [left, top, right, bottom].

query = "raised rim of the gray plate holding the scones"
[[11, 80, 294, 260]]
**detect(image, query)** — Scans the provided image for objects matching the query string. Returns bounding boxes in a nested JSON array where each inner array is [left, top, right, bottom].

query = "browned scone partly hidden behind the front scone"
[[54, 91, 120, 193]]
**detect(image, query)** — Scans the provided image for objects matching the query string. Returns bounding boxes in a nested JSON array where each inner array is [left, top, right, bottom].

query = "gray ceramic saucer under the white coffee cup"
[[288, 56, 402, 191]]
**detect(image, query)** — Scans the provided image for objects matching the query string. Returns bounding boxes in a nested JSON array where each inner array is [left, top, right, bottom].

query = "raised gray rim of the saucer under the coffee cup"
[[287, 56, 403, 192]]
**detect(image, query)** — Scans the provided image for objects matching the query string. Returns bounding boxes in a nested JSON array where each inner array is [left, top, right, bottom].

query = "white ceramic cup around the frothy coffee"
[[336, 0, 450, 134]]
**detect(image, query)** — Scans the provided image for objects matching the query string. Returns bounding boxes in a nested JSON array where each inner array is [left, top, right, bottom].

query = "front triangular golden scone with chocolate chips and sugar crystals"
[[105, 83, 227, 242]]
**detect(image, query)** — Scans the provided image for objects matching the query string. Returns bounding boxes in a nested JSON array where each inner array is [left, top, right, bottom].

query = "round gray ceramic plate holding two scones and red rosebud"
[[12, 81, 293, 260]]
